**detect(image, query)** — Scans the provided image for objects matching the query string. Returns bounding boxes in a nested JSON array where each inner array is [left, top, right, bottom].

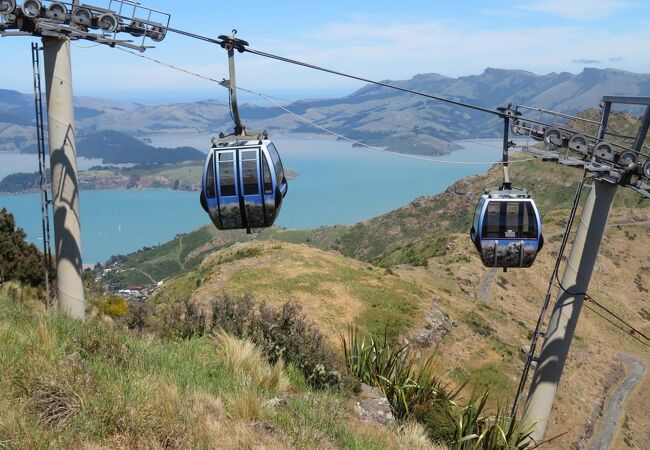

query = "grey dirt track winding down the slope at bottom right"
[[589, 354, 647, 450]]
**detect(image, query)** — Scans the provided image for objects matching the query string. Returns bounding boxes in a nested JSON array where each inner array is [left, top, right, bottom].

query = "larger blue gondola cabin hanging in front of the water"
[[201, 140, 288, 230]]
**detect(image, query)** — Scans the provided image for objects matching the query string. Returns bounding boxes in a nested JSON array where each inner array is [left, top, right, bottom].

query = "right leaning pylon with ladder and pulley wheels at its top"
[[513, 96, 650, 446]]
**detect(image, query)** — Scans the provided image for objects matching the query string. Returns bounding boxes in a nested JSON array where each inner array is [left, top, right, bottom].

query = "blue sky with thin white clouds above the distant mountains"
[[0, 0, 650, 103]]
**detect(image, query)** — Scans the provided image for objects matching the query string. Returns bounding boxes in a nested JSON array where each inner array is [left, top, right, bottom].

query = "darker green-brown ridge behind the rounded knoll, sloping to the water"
[[104, 149, 650, 284]]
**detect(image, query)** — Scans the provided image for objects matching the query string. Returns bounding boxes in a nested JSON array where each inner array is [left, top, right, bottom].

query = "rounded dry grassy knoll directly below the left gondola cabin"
[[153, 241, 432, 339]]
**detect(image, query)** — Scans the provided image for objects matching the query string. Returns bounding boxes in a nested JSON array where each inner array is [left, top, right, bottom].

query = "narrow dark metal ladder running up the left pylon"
[[32, 43, 52, 305]]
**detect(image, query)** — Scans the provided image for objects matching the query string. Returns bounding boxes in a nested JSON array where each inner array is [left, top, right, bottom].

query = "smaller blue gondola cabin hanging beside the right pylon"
[[470, 189, 544, 269]]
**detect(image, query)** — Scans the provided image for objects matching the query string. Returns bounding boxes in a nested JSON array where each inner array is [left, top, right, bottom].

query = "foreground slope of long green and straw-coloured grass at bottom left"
[[0, 284, 438, 449]]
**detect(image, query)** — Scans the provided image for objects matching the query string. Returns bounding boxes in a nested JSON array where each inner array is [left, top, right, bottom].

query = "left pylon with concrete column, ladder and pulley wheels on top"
[[0, 0, 170, 319]]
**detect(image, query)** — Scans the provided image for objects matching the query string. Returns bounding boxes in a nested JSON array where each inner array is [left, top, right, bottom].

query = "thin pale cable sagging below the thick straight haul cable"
[[116, 47, 537, 166]]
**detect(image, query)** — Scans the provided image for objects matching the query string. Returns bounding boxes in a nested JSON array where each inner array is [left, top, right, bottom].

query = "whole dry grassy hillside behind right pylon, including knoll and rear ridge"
[[105, 146, 650, 448]]
